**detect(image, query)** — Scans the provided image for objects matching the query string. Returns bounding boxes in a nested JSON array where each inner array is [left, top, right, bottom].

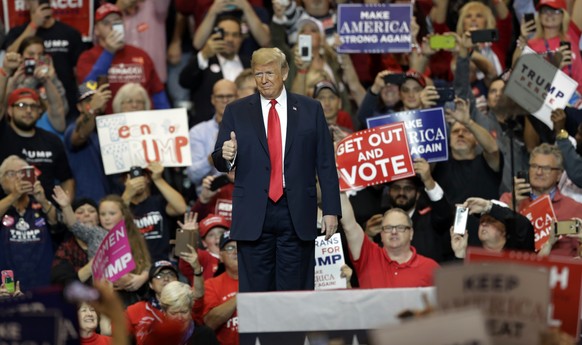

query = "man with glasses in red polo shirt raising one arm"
[[341, 193, 439, 289]]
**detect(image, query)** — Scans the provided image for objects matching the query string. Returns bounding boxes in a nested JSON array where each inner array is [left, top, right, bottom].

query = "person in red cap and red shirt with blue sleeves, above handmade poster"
[[77, 3, 170, 114]]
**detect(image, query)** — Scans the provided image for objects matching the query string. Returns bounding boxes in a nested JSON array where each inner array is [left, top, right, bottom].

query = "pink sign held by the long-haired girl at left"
[[91, 219, 135, 282]]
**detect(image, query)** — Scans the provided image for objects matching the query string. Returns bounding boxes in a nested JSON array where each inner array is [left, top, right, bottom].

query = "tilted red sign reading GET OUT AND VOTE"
[[335, 122, 415, 191]]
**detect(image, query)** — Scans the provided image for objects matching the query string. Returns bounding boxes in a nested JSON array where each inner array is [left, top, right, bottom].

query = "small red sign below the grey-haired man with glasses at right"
[[519, 194, 556, 252]]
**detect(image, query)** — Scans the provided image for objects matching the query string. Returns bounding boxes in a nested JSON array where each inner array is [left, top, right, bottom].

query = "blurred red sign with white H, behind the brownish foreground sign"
[[465, 247, 582, 339]]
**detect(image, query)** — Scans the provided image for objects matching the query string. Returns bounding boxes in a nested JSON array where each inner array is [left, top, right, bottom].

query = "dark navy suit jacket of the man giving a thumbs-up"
[[212, 92, 341, 241]]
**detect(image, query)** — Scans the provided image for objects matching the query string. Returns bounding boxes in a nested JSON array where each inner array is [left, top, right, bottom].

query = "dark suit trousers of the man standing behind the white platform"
[[237, 195, 315, 292]]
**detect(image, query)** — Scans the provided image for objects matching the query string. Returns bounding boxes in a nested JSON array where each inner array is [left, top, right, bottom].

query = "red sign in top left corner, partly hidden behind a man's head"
[[2, 0, 93, 42]]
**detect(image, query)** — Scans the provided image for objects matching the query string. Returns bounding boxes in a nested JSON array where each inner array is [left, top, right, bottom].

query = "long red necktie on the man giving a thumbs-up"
[[267, 99, 283, 202]]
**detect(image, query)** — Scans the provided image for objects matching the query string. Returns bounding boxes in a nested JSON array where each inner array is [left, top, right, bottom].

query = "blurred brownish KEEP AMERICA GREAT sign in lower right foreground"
[[435, 263, 550, 345]]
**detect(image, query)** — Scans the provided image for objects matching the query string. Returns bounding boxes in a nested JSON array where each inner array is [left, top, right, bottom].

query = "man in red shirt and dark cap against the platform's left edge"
[[203, 231, 239, 345]]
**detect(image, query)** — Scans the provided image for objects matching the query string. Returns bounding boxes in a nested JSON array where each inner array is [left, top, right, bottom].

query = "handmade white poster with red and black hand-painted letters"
[[97, 108, 192, 175]]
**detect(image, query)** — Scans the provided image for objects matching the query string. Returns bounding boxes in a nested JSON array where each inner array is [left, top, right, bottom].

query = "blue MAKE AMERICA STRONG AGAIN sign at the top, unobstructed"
[[337, 4, 412, 53]]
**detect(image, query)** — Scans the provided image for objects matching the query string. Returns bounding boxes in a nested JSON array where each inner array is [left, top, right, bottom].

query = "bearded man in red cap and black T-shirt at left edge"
[[0, 88, 75, 195]]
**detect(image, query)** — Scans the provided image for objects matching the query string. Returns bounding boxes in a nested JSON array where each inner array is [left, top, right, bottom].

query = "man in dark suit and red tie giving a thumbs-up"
[[212, 48, 341, 292]]
